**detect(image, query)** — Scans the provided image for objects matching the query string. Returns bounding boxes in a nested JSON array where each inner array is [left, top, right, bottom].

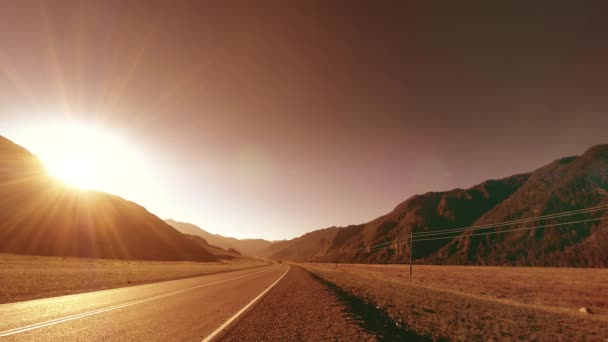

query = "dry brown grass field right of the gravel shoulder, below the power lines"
[[301, 264, 608, 341]]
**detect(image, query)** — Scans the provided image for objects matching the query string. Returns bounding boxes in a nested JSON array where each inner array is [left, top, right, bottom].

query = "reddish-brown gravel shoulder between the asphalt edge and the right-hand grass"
[[219, 266, 377, 341]]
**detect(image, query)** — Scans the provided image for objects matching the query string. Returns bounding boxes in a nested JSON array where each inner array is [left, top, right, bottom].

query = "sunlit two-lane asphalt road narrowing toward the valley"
[[0, 265, 288, 342]]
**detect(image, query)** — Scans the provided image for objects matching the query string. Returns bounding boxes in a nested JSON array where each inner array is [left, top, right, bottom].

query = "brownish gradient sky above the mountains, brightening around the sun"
[[0, 0, 608, 240]]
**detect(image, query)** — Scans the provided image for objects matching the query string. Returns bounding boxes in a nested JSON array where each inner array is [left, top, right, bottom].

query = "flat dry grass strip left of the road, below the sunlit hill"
[[0, 254, 268, 303]]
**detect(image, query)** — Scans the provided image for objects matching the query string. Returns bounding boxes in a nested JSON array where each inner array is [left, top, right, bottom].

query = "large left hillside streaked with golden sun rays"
[[0, 137, 223, 261]]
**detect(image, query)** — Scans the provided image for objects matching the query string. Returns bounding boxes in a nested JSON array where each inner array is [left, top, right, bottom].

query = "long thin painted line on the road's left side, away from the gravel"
[[0, 268, 272, 337]]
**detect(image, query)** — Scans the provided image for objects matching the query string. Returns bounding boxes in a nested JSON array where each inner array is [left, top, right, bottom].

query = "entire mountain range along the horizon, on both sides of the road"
[[0, 137, 608, 267]]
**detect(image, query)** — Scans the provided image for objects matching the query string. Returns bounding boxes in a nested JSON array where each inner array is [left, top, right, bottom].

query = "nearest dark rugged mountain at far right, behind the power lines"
[[430, 145, 608, 267]]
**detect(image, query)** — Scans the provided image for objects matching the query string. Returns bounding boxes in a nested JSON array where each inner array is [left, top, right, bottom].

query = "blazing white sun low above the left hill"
[[10, 122, 149, 193]]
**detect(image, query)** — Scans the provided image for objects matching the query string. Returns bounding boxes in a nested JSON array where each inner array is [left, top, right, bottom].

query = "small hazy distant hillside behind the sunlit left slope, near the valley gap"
[[165, 219, 273, 257]]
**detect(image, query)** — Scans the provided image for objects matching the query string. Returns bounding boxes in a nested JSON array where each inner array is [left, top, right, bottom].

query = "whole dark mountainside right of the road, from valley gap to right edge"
[[264, 145, 608, 267]]
